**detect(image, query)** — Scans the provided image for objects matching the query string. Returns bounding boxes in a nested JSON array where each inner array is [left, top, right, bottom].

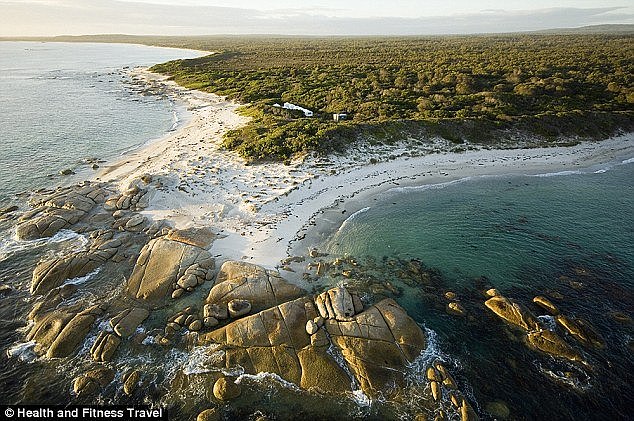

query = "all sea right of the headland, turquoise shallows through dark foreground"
[[318, 159, 634, 419]]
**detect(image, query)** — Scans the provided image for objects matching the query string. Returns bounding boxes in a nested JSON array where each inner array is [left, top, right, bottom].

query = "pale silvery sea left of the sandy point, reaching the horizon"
[[0, 42, 202, 205]]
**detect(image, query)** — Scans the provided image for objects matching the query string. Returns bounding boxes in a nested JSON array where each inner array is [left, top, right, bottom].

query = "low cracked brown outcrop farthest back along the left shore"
[[16, 182, 108, 240]]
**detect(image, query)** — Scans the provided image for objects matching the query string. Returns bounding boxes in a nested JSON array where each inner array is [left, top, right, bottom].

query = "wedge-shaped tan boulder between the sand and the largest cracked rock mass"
[[205, 261, 305, 312]]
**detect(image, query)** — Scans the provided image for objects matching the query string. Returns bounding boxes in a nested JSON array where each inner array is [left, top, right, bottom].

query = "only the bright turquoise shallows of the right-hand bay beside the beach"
[[326, 164, 634, 289]]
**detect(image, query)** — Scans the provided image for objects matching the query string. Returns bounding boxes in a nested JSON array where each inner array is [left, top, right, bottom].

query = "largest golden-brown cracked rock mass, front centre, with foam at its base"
[[197, 277, 425, 396]]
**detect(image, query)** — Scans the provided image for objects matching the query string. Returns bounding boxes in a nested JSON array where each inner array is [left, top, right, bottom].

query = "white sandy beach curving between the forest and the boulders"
[[97, 70, 634, 267]]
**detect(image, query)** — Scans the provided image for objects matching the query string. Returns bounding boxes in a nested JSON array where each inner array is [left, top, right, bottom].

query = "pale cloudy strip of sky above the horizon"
[[0, 0, 634, 36]]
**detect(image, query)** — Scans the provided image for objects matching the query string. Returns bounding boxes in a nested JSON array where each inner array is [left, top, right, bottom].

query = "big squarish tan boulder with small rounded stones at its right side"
[[127, 237, 214, 307]]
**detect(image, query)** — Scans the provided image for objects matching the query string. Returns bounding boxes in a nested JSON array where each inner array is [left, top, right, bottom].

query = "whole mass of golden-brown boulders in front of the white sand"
[[9, 175, 477, 419]]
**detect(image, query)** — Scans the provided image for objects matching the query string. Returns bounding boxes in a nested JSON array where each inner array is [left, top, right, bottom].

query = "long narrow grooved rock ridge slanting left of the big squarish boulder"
[[31, 231, 122, 294]]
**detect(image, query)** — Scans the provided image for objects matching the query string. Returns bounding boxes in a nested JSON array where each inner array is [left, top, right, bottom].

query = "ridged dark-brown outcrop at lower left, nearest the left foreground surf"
[[27, 306, 104, 358]]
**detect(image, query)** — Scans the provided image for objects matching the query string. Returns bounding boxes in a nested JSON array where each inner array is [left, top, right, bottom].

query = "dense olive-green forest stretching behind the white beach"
[[81, 34, 634, 159]]
